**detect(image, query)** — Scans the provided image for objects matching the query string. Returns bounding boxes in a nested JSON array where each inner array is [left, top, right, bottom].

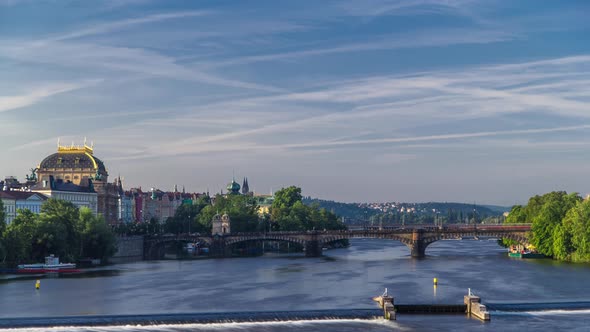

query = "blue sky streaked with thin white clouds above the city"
[[0, 0, 590, 205]]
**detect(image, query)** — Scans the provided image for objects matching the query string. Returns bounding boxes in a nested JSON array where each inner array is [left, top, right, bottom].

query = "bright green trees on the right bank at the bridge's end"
[[506, 191, 590, 262]]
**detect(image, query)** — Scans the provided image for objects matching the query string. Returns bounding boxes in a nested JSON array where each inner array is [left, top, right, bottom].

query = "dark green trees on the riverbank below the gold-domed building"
[[0, 199, 116, 266]]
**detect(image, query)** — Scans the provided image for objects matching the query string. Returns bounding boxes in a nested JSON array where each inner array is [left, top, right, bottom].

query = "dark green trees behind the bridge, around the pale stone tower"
[[115, 186, 345, 235]]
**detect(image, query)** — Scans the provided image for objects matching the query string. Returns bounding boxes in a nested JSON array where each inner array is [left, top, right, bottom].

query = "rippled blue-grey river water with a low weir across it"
[[0, 239, 590, 332]]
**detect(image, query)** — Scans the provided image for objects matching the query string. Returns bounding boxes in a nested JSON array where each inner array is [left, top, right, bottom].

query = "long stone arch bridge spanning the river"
[[144, 224, 531, 259]]
